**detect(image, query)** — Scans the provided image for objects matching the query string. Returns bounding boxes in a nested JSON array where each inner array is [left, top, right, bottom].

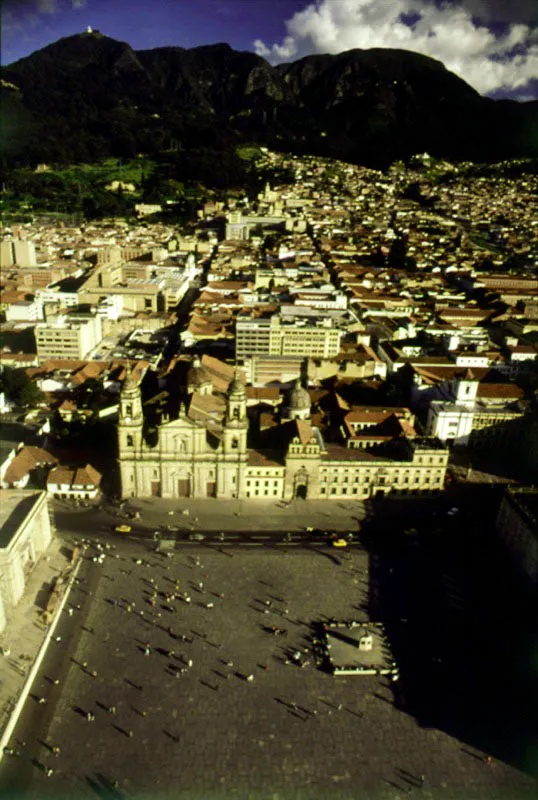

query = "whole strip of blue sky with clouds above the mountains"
[[0, 0, 538, 101]]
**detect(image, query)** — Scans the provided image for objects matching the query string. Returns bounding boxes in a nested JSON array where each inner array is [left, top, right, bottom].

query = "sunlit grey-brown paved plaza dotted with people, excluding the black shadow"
[[0, 540, 537, 800]]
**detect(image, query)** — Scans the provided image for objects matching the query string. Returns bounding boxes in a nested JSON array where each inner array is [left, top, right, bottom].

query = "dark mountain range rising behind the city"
[[0, 32, 538, 166]]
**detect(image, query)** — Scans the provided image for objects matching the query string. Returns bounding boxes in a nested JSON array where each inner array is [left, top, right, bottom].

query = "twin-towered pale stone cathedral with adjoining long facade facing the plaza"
[[118, 356, 448, 500]]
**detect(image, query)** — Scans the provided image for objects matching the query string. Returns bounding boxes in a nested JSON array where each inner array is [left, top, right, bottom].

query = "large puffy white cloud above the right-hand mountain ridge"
[[254, 0, 538, 94]]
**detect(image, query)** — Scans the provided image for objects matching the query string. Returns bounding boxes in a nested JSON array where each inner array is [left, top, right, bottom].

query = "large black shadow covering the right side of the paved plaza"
[[361, 494, 538, 776]]
